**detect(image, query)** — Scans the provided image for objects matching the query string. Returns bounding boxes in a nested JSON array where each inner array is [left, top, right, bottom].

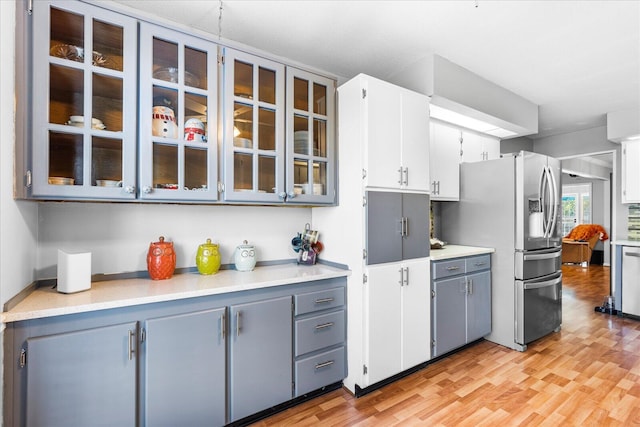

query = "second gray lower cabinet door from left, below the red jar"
[[140, 308, 226, 427]]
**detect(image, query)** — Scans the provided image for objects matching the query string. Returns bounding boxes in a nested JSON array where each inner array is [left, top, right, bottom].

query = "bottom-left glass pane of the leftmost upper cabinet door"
[[49, 131, 84, 185]]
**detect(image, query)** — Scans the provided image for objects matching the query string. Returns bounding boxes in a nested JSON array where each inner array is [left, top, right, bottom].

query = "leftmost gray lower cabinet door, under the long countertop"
[[23, 322, 137, 427]]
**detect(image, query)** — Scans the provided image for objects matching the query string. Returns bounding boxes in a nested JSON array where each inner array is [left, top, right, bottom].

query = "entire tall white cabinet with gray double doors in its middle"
[[312, 74, 431, 395]]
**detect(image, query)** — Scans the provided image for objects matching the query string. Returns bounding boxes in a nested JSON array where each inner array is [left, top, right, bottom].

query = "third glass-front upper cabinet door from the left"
[[223, 48, 286, 203]]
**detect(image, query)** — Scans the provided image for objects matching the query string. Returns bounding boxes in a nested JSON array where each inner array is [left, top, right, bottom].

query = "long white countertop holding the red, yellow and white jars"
[[2, 263, 350, 323]]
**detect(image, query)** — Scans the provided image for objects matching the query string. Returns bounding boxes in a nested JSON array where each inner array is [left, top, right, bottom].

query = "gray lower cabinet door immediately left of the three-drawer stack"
[[229, 296, 292, 421]]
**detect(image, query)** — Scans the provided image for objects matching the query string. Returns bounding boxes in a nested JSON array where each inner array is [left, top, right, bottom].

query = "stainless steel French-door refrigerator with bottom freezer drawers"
[[440, 151, 562, 351]]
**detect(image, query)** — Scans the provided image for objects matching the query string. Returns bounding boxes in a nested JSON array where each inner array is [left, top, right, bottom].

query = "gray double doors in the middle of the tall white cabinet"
[[366, 191, 429, 264]]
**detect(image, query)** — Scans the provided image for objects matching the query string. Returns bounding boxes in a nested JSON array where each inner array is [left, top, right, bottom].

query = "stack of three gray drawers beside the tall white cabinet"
[[293, 287, 347, 397]]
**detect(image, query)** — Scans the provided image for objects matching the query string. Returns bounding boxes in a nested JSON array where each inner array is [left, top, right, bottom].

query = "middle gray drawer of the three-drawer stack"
[[294, 310, 345, 357]]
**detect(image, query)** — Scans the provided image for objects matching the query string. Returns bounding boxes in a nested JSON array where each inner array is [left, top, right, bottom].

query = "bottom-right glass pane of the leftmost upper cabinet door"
[[91, 137, 122, 187]]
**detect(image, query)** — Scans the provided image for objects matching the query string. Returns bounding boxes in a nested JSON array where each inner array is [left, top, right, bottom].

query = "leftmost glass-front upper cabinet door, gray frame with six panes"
[[27, 1, 137, 199]]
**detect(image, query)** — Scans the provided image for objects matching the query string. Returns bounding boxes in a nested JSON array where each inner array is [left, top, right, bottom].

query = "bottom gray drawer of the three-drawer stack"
[[295, 347, 345, 397]]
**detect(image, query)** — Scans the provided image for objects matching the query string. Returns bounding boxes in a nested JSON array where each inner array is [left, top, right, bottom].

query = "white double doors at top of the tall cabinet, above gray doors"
[[356, 74, 429, 192]]
